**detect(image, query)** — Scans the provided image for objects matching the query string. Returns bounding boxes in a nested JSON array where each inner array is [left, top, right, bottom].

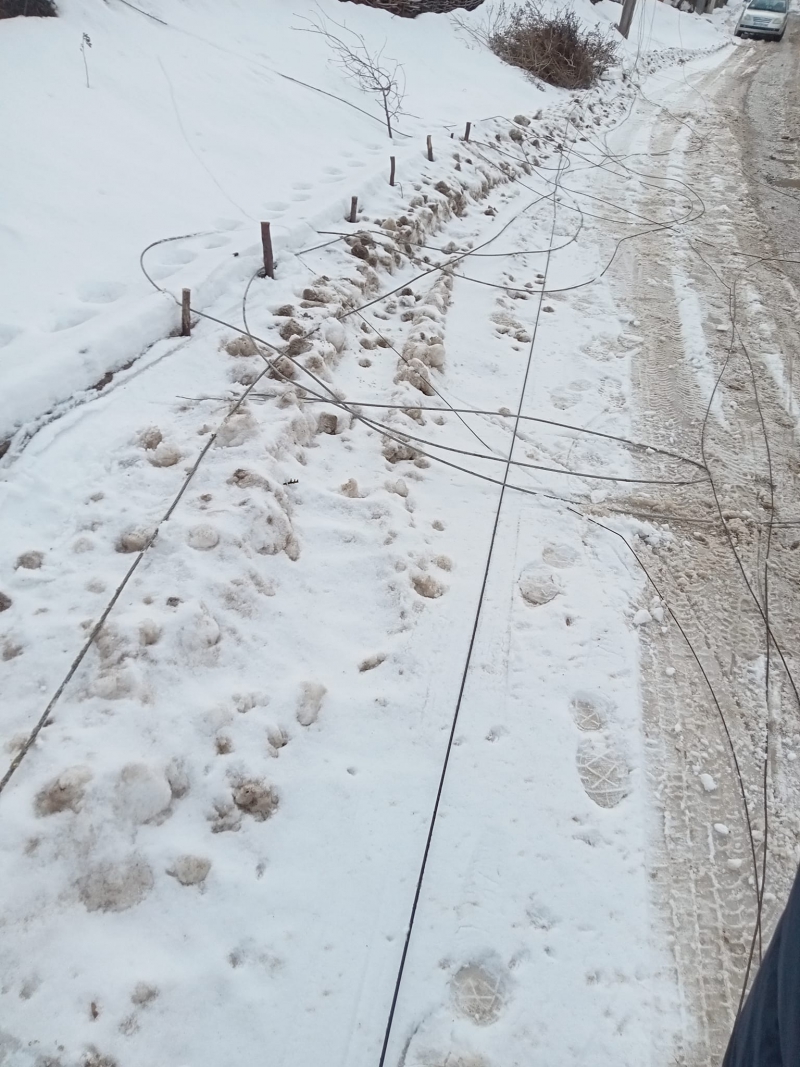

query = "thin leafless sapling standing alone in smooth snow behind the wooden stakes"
[[296, 9, 405, 137]]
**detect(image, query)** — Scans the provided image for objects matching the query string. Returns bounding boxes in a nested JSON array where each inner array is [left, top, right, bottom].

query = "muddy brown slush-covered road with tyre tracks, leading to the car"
[[609, 20, 800, 1065]]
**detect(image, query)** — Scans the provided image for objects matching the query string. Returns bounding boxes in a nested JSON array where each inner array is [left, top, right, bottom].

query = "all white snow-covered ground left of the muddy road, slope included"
[[0, 0, 750, 1067]]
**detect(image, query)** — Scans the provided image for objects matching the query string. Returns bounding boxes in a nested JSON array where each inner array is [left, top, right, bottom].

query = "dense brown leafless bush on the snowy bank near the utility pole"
[[460, 0, 617, 89]]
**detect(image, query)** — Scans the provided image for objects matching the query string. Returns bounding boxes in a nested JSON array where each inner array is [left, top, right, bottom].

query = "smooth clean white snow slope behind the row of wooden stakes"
[[0, 0, 720, 439]]
